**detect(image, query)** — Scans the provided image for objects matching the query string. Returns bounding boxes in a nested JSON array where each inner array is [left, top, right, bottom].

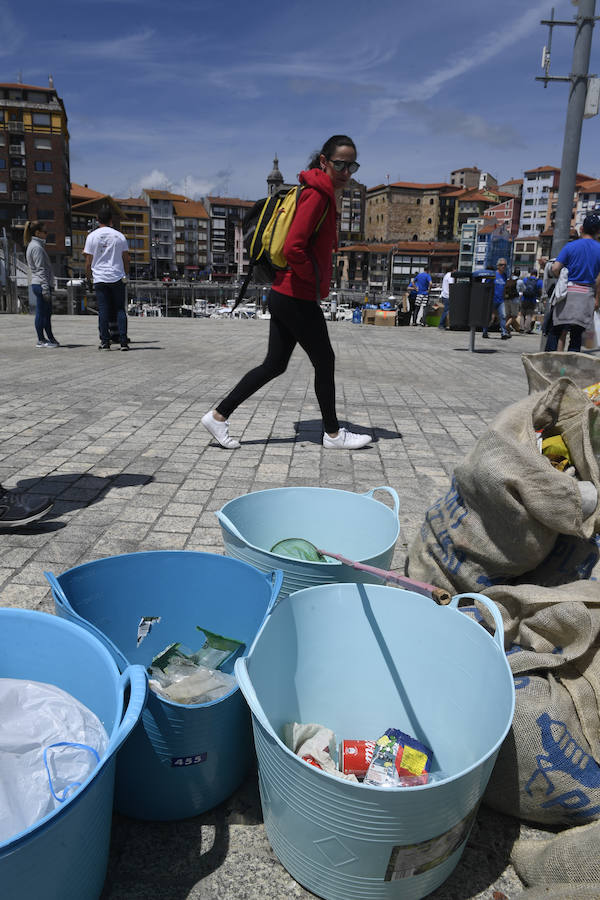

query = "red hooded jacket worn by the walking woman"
[[273, 169, 337, 300]]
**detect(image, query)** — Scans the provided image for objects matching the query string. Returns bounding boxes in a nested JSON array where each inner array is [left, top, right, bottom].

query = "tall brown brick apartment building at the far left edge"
[[0, 78, 71, 277]]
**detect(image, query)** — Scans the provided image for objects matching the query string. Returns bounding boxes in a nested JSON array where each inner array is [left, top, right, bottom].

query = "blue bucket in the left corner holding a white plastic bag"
[[0, 608, 147, 900]]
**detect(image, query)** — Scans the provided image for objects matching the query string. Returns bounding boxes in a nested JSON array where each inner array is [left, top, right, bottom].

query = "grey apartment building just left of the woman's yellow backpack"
[[203, 197, 255, 280]]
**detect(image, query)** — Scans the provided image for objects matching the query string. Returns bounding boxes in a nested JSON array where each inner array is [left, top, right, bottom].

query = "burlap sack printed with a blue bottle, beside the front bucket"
[[481, 581, 600, 825]]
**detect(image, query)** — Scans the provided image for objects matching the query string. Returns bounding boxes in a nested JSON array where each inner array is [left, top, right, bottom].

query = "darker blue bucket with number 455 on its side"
[[46, 551, 281, 820]]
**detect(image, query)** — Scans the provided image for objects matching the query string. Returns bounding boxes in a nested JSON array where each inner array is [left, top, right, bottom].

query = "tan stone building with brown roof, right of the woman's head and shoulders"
[[365, 181, 456, 242]]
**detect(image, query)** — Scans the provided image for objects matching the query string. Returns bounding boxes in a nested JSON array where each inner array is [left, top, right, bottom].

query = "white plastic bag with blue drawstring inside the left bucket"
[[0, 678, 108, 841]]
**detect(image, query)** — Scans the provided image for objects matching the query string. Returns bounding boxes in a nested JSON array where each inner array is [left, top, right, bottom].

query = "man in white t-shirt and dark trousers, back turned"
[[83, 205, 129, 350]]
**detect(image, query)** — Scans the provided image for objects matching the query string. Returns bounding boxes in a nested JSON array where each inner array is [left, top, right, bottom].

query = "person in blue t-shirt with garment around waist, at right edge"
[[545, 213, 600, 352]]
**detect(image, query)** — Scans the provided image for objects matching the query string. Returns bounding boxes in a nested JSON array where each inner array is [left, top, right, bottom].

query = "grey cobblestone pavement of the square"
[[0, 316, 552, 900]]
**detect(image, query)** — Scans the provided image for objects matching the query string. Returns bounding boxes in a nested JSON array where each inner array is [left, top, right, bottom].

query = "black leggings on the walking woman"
[[216, 290, 339, 434]]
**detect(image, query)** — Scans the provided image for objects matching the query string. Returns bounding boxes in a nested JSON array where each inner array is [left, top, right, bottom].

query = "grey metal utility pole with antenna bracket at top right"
[[536, 0, 596, 257]]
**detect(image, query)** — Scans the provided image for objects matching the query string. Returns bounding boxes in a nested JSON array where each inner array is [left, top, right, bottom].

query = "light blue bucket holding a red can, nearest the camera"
[[235, 584, 514, 900]]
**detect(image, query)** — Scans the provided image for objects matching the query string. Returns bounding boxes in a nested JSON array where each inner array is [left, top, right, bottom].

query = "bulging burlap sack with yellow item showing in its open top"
[[405, 378, 600, 593]]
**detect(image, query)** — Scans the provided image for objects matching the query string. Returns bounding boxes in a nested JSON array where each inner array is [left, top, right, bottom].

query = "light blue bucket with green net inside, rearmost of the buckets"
[[216, 486, 400, 597]]
